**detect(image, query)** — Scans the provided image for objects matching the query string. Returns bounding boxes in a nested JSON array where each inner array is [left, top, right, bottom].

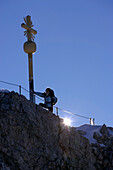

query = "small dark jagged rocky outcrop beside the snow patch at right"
[[92, 124, 113, 170]]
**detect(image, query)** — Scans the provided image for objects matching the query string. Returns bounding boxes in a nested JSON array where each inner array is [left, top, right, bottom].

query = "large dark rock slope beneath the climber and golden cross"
[[0, 92, 113, 170]]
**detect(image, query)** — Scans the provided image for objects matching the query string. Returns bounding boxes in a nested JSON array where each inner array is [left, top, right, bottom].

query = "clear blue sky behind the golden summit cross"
[[0, 0, 113, 126]]
